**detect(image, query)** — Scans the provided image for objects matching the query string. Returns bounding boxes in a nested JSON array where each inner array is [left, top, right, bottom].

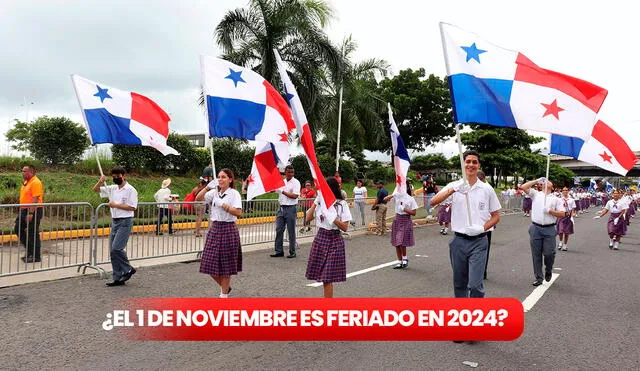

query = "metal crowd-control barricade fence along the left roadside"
[[0, 195, 424, 277]]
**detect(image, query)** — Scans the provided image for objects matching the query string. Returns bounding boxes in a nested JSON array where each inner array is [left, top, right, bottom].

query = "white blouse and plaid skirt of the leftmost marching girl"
[[200, 188, 242, 277]]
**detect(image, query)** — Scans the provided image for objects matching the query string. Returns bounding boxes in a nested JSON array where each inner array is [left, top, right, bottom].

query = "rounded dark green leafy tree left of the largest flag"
[[378, 68, 455, 151]]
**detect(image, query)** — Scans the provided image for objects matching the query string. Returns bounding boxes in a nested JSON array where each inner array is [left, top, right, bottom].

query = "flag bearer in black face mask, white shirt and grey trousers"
[[93, 166, 138, 286]]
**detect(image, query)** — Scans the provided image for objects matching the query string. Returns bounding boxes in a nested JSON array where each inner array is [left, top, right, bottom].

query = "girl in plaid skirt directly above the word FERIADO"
[[305, 177, 351, 298]]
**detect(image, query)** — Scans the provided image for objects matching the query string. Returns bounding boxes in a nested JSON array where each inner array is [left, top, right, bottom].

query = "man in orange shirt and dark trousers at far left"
[[15, 165, 44, 263]]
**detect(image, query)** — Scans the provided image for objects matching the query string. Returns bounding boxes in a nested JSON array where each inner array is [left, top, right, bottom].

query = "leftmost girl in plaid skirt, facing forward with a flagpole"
[[200, 169, 242, 299]]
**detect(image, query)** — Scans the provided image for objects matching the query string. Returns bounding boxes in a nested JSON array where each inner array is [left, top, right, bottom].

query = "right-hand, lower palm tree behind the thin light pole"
[[319, 36, 389, 153]]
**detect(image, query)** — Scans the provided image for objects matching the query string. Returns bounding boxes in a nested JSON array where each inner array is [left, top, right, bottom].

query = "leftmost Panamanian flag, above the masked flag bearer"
[[71, 75, 179, 156]]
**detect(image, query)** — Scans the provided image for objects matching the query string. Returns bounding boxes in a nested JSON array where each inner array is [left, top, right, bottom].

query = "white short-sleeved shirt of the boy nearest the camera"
[[441, 179, 500, 233]]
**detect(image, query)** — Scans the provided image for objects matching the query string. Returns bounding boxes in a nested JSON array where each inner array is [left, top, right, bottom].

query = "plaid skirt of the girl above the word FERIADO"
[[306, 228, 347, 283]]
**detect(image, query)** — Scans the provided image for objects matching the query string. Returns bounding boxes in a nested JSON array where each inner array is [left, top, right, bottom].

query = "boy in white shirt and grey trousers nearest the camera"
[[431, 151, 500, 298]]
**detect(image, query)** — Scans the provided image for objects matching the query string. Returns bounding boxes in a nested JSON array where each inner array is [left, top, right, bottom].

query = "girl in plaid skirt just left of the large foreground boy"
[[384, 179, 418, 269]]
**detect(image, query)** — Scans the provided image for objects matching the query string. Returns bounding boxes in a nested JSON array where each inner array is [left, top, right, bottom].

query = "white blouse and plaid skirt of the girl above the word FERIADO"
[[305, 200, 352, 283]]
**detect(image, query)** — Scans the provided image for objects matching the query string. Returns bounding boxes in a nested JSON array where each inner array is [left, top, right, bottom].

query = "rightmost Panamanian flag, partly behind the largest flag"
[[551, 120, 638, 176]]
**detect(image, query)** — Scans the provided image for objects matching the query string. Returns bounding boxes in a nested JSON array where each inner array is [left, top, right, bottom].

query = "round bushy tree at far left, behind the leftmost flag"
[[5, 116, 90, 165]]
